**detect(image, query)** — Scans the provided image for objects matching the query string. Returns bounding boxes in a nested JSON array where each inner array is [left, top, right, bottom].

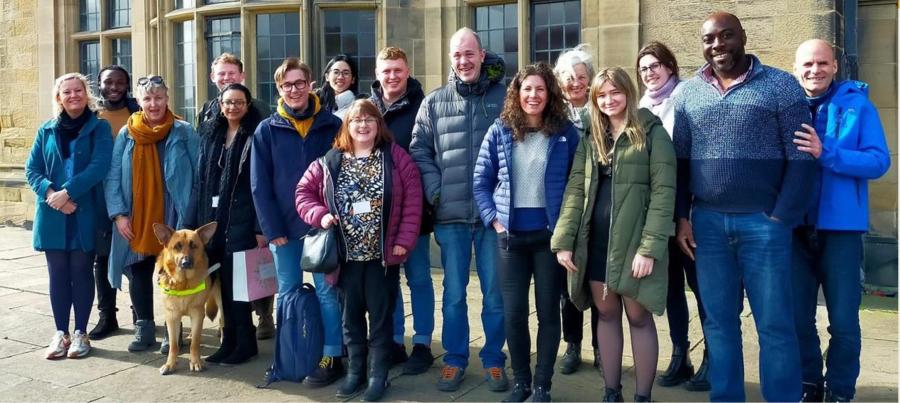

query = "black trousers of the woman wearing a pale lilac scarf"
[[666, 237, 706, 349]]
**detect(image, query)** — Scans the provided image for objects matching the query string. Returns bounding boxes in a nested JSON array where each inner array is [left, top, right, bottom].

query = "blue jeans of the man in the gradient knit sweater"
[[692, 208, 801, 402]]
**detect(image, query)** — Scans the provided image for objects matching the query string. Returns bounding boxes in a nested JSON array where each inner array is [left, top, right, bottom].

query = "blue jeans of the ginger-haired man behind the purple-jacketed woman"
[[394, 234, 434, 346]]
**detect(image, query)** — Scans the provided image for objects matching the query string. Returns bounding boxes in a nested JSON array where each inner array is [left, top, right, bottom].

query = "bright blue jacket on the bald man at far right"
[[815, 81, 891, 231]]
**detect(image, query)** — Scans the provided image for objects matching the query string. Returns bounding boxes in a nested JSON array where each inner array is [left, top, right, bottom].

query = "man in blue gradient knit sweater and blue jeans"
[[673, 12, 817, 401]]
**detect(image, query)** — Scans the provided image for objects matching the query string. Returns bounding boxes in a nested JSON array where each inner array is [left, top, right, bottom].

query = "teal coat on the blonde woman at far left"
[[25, 111, 112, 252]]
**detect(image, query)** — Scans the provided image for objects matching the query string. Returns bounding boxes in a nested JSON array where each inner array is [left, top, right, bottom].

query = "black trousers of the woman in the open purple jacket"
[[340, 260, 400, 376]]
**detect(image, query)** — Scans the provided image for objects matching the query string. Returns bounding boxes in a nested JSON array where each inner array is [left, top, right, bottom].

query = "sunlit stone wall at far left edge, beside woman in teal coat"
[[0, 0, 40, 224]]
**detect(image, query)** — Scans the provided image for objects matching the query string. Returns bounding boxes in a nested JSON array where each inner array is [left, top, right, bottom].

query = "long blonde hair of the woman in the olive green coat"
[[590, 67, 647, 165]]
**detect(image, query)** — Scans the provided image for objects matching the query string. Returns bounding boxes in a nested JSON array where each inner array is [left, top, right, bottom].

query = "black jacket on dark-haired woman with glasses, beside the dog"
[[197, 110, 262, 263]]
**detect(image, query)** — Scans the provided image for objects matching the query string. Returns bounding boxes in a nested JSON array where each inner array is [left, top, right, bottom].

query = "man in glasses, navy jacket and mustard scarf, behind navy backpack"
[[250, 57, 344, 387]]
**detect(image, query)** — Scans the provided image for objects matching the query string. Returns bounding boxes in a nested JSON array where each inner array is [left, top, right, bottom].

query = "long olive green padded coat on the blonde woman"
[[550, 109, 675, 315]]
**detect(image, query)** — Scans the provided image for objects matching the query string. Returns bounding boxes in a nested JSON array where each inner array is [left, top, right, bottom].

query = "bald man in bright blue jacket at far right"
[[793, 39, 891, 402]]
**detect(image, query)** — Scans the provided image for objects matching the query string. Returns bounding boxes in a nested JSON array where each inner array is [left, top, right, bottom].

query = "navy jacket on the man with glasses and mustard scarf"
[[250, 106, 341, 241]]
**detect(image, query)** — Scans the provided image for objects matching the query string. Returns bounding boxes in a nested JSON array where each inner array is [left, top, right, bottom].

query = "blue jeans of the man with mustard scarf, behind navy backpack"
[[269, 239, 344, 357]]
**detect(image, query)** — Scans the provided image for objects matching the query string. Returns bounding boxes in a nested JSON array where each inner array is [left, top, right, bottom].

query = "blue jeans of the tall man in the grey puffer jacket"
[[434, 224, 506, 369]]
